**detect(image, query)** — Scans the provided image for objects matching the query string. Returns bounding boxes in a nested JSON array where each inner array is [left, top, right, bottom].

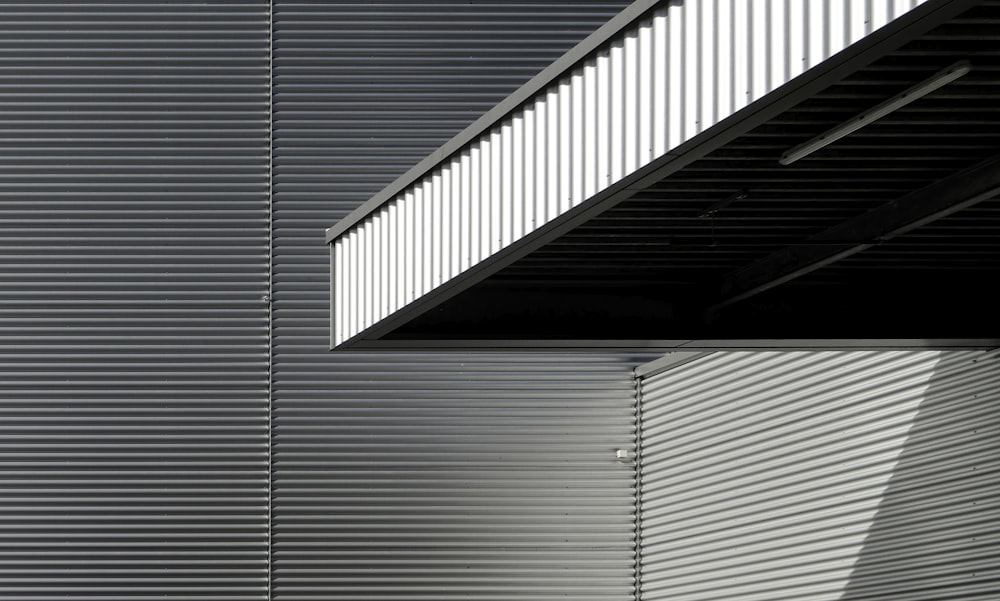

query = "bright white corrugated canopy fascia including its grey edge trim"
[[327, 0, 944, 346]]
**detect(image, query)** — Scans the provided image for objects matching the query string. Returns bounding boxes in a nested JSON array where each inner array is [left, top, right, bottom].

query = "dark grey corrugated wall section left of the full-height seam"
[[0, 0, 268, 600]]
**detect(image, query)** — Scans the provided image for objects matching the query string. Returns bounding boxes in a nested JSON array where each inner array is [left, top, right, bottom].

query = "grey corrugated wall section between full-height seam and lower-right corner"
[[273, 1, 637, 601]]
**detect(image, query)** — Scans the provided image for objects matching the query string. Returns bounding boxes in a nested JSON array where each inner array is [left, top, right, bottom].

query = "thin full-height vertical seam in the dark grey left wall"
[[266, 0, 274, 601]]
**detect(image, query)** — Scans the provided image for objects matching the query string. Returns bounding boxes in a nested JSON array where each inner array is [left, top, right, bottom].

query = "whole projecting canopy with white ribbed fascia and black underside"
[[328, 0, 1000, 346]]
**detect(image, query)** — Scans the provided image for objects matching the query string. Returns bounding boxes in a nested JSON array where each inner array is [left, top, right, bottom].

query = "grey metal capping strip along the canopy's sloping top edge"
[[326, 0, 668, 244]]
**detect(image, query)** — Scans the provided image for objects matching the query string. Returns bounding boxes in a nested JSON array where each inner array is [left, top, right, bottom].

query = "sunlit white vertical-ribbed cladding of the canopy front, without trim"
[[331, 0, 921, 345]]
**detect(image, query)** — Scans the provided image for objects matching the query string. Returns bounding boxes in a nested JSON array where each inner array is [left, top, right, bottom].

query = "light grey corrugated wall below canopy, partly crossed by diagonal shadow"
[[641, 351, 1000, 601]]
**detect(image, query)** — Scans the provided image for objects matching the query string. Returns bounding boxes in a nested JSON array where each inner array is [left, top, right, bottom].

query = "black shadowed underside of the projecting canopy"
[[386, 0, 1000, 339]]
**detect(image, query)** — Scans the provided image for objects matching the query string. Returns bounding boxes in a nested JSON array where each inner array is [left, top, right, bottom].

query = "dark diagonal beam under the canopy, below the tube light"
[[706, 156, 1000, 317]]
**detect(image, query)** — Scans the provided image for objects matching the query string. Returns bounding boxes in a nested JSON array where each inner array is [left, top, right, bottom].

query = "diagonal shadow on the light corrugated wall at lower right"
[[841, 352, 1000, 601]]
